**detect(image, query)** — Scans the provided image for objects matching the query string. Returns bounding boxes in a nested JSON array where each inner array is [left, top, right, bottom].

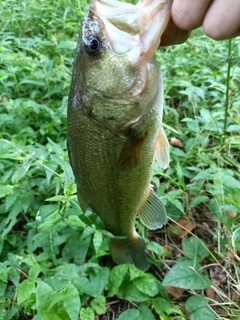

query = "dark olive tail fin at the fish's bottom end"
[[110, 235, 149, 271]]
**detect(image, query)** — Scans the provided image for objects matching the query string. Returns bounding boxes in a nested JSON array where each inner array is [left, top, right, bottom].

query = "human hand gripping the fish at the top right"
[[161, 0, 240, 46]]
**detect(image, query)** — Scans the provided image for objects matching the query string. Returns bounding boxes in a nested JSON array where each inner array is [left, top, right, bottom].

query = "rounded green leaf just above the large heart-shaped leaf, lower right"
[[182, 237, 209, 260]]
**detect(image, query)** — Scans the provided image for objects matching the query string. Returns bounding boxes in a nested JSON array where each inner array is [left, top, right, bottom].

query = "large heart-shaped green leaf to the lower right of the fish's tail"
[[162, 260, 212, 290]]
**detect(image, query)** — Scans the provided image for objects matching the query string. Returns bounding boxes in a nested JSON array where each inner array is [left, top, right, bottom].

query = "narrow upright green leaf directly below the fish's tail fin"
[[108, 264, 128, 297]]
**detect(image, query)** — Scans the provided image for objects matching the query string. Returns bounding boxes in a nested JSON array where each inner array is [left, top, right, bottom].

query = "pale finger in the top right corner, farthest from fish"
[[203, 0, 240, 40]]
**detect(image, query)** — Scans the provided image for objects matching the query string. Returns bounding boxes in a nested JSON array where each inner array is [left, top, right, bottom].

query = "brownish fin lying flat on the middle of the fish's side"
[[118, 135, 145, 170]]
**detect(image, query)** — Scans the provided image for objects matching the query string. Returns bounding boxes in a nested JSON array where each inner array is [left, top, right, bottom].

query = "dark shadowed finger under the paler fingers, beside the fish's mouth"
[[160, 19, 190, 46]]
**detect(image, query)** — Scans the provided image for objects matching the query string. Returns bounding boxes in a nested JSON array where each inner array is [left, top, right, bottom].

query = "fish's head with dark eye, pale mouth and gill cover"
[[74, 0, 172, 123]]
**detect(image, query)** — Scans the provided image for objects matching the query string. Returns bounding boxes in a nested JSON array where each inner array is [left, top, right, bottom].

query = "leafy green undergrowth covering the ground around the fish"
[[0, 0, 240, 320]]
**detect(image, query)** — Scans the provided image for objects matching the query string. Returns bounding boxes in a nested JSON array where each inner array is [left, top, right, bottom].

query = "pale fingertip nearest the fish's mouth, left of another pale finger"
[[172, 0, 213, 30]]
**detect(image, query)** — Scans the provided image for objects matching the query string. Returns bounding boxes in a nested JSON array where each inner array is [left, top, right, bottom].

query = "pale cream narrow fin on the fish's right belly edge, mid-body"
[[156, 128, 170, 169]]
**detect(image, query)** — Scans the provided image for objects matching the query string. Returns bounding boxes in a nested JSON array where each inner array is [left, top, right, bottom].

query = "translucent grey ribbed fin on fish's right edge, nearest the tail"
[[138, 190, 167, 230]]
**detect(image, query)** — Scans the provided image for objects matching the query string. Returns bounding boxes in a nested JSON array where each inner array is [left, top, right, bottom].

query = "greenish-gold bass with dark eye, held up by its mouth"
[[67, 0, 172, 271]]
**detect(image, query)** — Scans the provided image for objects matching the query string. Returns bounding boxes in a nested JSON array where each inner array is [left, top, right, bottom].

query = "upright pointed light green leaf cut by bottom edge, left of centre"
[[63, 283, 81, 320]]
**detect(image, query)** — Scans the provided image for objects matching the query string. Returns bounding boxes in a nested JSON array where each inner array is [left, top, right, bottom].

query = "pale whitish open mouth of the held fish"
[[91, 0, 172, 61]]
